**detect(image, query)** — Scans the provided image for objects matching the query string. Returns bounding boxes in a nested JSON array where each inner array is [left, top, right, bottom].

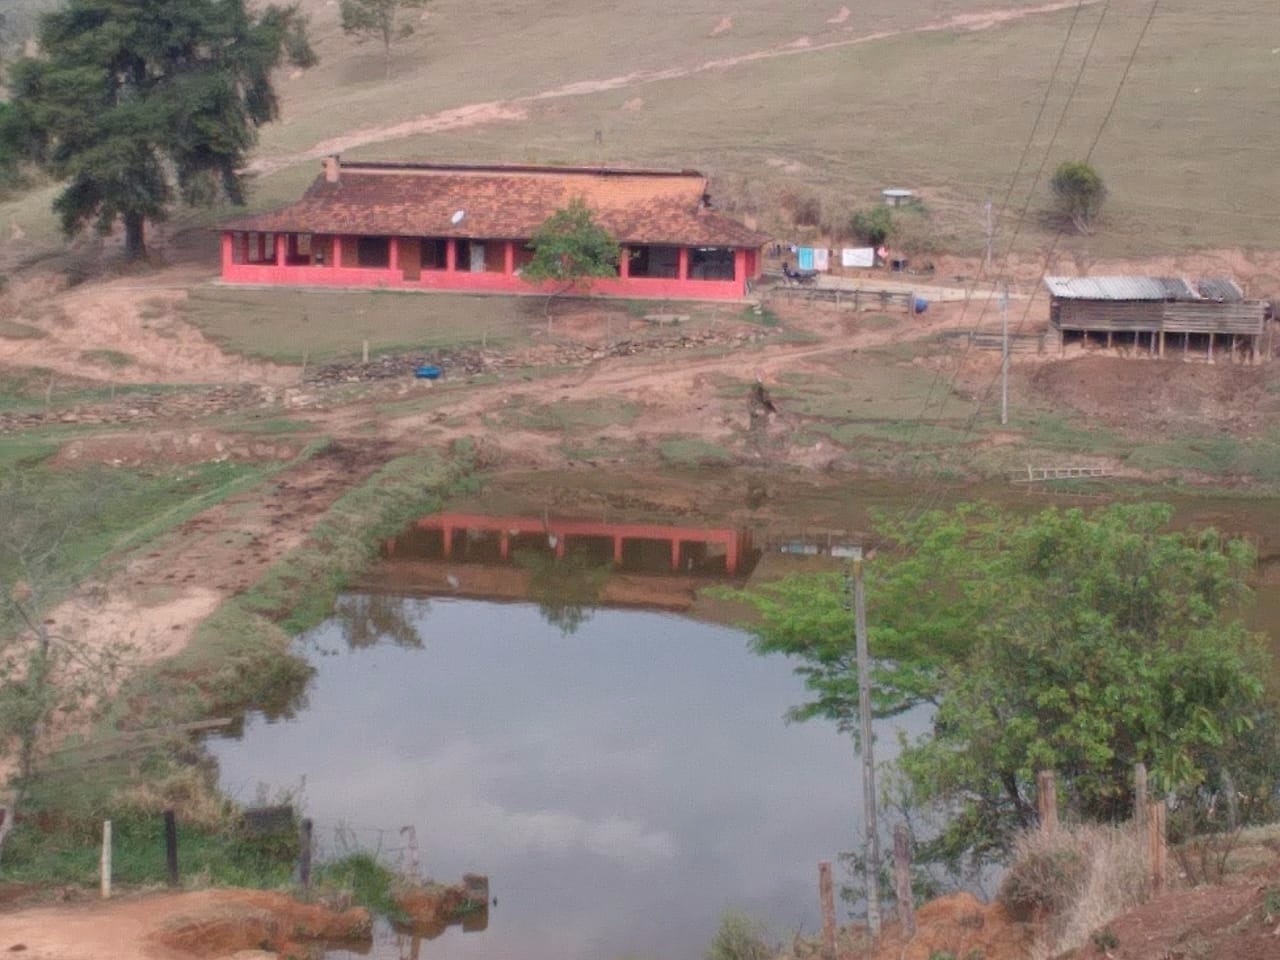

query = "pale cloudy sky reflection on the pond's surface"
[[211, 595, 921, 960]]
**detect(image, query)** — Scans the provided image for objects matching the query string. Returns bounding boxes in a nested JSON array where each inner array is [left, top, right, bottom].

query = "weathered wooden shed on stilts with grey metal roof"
[[1044, 276, 1267, 362]]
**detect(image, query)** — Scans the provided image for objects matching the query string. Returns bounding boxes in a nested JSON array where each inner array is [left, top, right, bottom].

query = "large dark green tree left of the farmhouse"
[[4, 0, 315, 259]]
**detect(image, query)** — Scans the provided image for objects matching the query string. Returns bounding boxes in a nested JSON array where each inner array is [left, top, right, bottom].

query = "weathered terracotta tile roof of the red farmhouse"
[[221, 164, 769, 247]]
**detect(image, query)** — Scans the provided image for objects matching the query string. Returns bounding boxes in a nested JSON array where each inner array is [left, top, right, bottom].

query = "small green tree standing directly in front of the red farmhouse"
[[521, 198, 620, 325]]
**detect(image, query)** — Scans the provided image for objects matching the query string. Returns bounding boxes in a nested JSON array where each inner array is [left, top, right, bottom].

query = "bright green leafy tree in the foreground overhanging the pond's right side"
[[745, 504, 1275, 863]]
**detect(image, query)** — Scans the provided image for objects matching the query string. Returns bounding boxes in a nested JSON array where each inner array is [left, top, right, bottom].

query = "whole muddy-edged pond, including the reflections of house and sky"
[[204, 492, 1280, 960]]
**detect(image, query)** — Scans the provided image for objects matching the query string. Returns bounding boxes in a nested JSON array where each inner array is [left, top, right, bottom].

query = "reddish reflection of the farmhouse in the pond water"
[[378, 513, 759, 609]]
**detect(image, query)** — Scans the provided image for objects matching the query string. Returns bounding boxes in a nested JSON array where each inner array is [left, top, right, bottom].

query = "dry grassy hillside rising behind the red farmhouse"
[[0, 0, 1280, 256]]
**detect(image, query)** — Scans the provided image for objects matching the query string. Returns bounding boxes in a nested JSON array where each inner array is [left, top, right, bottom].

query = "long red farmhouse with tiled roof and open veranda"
[[223, 156, 767, 300]]
